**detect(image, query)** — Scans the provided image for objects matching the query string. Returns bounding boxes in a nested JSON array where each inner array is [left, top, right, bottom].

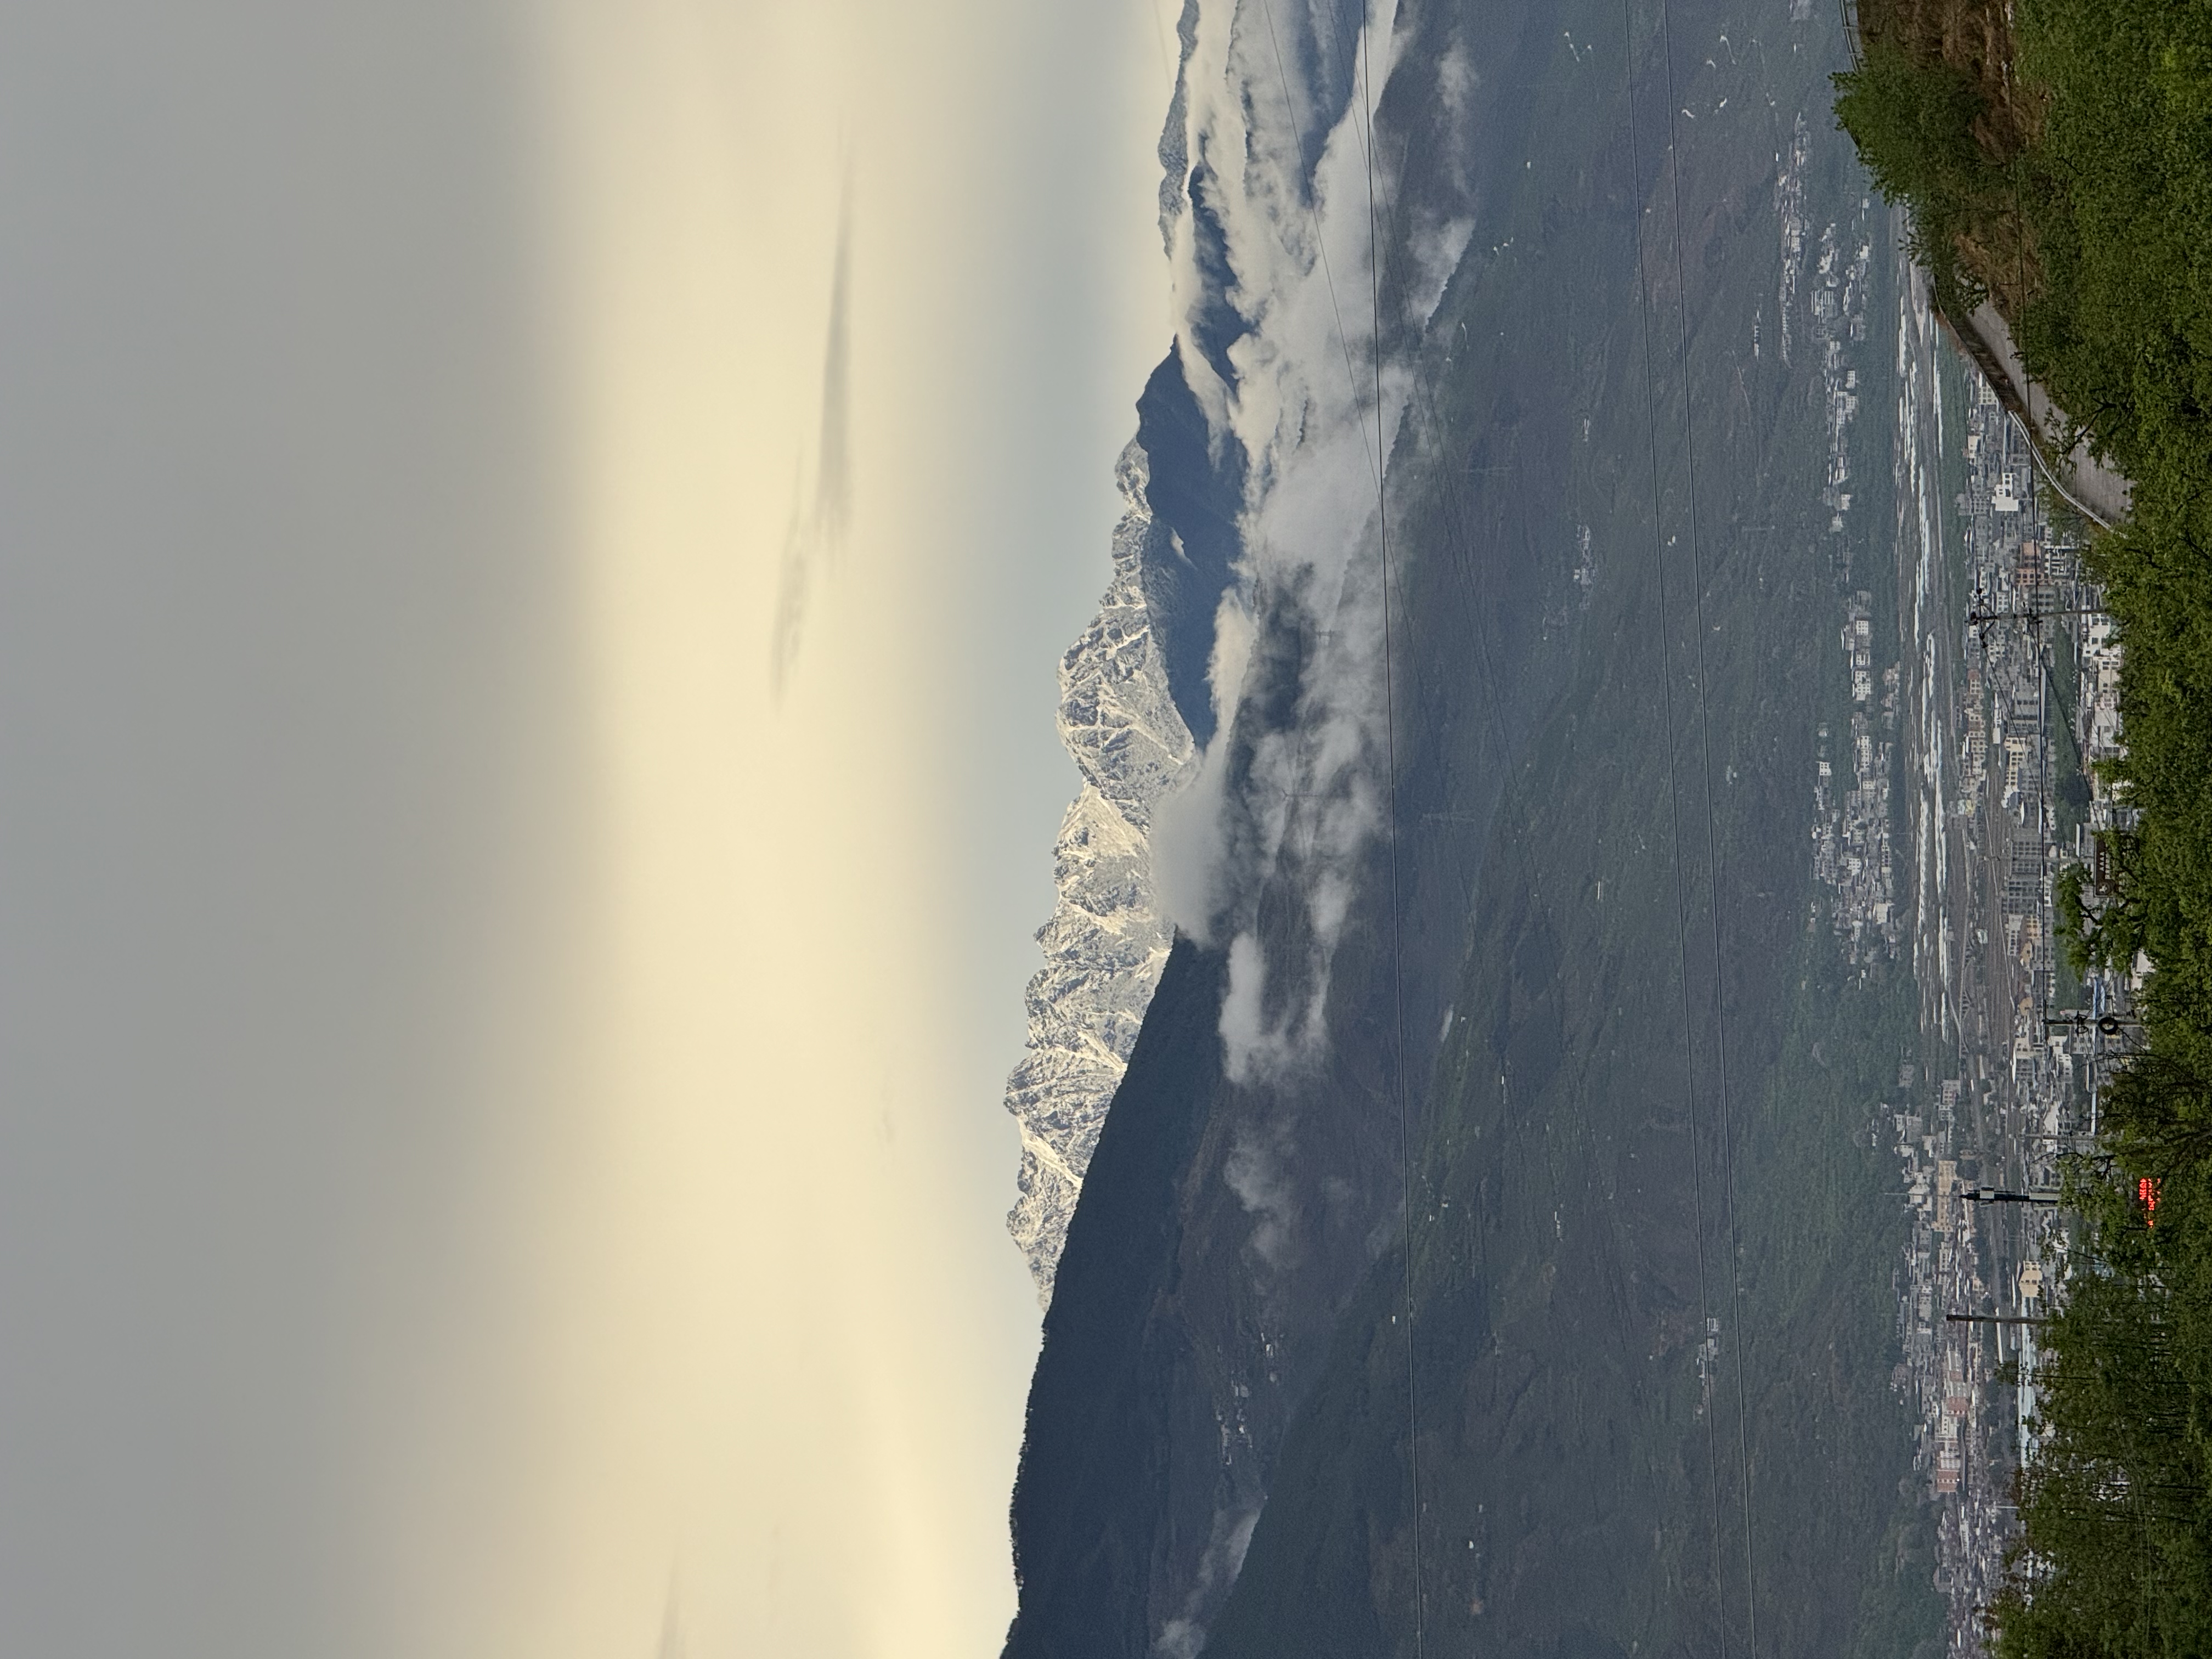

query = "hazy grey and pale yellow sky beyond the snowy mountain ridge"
[[0, 0, 1170, 1659]]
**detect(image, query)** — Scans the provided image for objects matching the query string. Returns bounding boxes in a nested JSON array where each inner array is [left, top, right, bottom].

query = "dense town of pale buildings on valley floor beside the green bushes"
[[1876, 347, 2135, 1655]]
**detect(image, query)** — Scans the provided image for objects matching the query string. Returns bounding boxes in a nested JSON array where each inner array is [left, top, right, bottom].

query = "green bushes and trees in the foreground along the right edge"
[[1836, 0, 2212, 1655]]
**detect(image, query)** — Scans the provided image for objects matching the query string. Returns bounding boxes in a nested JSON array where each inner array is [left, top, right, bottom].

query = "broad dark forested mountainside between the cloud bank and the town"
[[1009, 0, 1942, 1659]]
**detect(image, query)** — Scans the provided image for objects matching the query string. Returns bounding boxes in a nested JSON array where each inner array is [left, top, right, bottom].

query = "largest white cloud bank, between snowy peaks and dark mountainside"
[[1155, 0, 1473, 1080]]
